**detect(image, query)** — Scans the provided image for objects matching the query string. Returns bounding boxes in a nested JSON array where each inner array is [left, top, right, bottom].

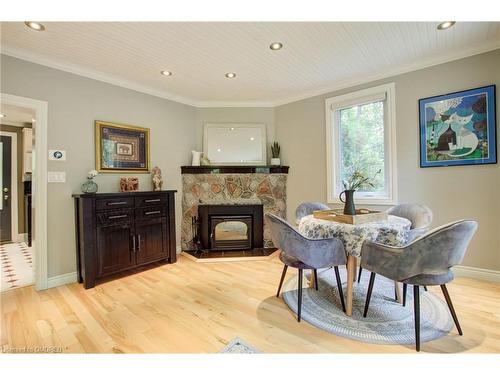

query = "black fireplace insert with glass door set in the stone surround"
[[198, 203, 263, 251]]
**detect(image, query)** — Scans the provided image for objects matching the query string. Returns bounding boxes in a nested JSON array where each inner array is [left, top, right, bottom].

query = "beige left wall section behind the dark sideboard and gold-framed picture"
[[1, 55, 196, 277]]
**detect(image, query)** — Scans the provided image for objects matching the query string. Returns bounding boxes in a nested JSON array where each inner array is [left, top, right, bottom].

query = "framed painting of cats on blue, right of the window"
[[419, 85, 497, 167]]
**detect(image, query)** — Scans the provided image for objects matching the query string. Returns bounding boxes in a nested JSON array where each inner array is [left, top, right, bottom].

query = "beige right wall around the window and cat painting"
[[275, 50, 500, 270]]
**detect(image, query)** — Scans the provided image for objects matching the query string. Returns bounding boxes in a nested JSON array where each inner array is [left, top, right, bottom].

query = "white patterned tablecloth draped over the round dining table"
[[298, 215, 411, 257]]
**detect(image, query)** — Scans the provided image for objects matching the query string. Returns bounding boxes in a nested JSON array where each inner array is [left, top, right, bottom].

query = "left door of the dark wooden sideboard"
[[97, 223, 135, 276]]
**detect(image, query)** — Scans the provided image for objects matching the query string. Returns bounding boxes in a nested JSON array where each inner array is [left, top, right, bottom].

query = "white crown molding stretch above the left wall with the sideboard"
[[1, 45, 196, 107]]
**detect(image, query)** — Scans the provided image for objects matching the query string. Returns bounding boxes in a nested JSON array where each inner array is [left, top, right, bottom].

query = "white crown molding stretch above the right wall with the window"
[[273, 40, 500, 107]]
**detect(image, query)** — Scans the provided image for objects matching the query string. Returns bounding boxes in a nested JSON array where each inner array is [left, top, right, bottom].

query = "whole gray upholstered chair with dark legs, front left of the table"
[[265, 213, 347, 322]]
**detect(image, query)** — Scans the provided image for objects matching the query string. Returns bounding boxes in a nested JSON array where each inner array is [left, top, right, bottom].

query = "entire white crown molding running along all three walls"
[[1, 40, 500, 108]]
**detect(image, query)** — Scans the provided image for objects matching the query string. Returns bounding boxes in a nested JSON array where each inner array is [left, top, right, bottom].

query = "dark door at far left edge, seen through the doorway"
[[0, 135, 12, 243]]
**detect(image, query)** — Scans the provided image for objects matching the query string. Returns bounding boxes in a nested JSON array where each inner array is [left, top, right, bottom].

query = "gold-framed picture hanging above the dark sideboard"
[[95, 121, 150, 173]]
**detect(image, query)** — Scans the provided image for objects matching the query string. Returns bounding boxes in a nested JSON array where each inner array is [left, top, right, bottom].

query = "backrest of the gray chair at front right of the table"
[[400, 220, 478, 277]]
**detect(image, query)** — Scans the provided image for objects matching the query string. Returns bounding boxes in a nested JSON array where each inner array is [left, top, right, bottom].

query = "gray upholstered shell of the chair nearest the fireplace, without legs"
[[265, 213, 346, 268]]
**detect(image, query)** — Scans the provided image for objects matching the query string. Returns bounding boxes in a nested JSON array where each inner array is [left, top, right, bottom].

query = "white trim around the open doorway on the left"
[[0, 93, 48, 290]]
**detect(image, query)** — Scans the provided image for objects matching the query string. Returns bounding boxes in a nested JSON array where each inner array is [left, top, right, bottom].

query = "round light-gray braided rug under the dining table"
[[283, 268, 453, 344]]
